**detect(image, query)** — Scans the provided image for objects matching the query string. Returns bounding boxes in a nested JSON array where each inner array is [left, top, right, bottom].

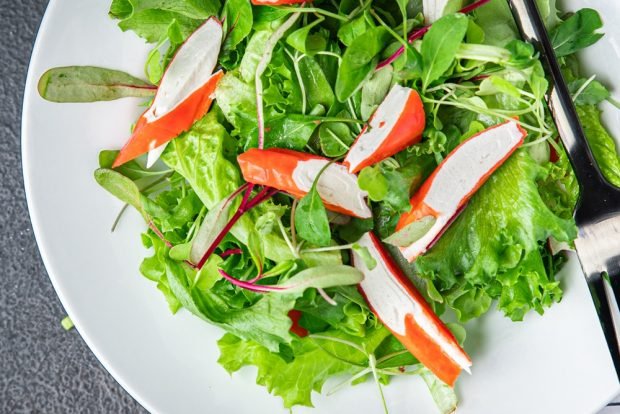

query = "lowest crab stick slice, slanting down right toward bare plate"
[[353, 232, 472, 386]]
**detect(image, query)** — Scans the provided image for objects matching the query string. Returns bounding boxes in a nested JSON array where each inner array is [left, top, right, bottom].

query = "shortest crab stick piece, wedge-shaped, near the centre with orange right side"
[[344, 85, 426, 173]]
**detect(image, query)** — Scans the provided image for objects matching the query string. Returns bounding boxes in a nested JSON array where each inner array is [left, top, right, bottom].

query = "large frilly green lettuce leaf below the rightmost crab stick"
[[415, 150, 577, 321]]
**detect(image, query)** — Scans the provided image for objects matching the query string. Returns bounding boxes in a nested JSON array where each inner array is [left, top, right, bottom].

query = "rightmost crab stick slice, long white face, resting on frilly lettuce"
[[393, 121, 527, 262]]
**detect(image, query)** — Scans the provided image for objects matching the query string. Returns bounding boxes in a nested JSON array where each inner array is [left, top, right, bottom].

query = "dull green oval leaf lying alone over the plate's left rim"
[[37, 66, 157, 102]]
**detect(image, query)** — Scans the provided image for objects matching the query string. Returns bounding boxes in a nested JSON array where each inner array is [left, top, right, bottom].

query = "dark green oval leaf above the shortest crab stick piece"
[[335, 27, 390, 102]]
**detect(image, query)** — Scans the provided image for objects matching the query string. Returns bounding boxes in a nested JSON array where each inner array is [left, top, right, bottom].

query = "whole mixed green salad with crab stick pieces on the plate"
[[39, 0, 620, 413]]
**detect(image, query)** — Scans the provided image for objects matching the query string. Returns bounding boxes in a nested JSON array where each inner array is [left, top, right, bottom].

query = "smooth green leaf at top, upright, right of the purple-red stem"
[[421, 13, 469, 89]]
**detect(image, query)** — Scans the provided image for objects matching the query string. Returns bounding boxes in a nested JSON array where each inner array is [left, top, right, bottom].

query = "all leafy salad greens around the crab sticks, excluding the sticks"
[[39, 0, 620, 413]]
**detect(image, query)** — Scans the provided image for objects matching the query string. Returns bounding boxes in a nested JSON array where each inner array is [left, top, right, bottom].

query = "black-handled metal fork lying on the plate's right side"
[[508, 0, 620, 379]]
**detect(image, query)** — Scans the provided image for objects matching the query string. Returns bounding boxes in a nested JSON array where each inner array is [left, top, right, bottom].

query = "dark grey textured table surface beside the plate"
[[0, 0, 620, 414]]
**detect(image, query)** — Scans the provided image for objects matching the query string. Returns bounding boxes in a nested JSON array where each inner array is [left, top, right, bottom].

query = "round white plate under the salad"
[[23, 0, 620, 414]]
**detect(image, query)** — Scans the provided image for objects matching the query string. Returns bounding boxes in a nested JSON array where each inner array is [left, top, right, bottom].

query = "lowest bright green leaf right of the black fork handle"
[[577, 105, 620, 187]]
